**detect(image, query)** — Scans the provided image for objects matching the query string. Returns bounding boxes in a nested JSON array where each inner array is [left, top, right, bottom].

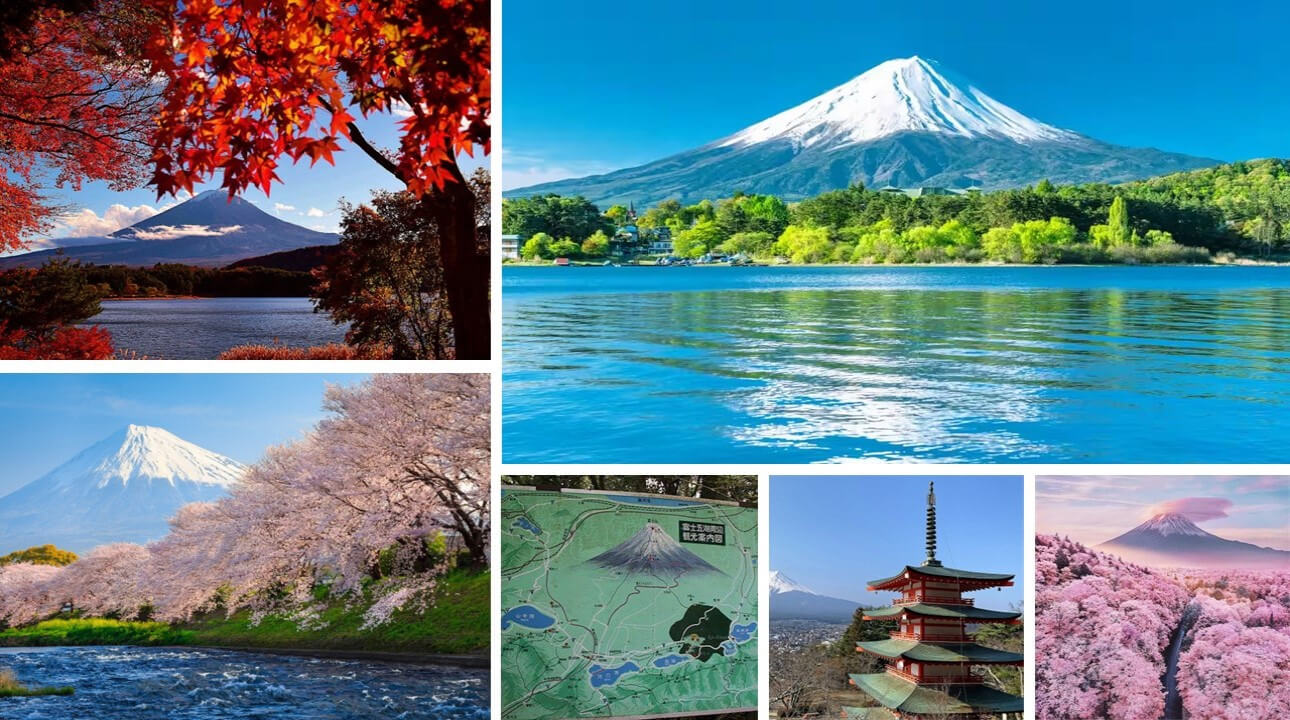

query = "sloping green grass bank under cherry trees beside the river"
[[183, 570, 489, 654]]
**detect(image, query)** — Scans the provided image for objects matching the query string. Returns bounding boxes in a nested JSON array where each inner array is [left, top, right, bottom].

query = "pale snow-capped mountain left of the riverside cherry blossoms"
[[0, 425, 246, 552]]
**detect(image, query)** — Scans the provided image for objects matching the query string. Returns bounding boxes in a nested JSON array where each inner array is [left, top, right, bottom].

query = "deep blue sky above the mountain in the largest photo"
[[502, 0, 1290, 188]]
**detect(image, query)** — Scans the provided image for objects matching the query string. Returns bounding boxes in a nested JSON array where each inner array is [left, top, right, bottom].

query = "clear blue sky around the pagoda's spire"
[[770, 476, 1026, 609]]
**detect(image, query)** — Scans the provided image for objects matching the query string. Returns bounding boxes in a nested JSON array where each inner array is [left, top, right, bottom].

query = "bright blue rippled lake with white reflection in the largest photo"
[[502, 267, 1290, 463]]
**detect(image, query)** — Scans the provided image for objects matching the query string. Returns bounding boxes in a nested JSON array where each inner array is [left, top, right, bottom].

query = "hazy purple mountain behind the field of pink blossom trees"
[[1097, 512, 1290, 569]]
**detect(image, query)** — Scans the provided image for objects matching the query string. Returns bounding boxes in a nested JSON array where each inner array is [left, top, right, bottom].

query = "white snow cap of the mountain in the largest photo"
[[716, 55, 1080, 147]]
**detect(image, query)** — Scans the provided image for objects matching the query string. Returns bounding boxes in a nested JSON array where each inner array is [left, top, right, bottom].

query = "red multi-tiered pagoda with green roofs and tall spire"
[[842, 484, 1024, 720]]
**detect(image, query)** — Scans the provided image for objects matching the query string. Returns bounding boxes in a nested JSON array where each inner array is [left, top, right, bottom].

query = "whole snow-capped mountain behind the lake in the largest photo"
[[508, 57, 1218, 206]]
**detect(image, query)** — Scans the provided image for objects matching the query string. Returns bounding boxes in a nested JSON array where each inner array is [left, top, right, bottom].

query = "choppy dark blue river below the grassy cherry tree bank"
[[0, 648, 489, 720]]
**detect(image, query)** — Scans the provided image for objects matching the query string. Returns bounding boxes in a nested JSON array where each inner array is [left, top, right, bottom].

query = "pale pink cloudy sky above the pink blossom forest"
[[1035, 475, 1290, 550]]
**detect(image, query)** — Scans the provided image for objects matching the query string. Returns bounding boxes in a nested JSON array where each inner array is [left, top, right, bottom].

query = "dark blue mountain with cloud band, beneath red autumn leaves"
[[0, 190, 339, 267]]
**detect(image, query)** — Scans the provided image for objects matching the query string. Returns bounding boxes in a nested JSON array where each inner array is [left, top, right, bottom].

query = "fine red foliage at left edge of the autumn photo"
[[0, 0, 157, 250]]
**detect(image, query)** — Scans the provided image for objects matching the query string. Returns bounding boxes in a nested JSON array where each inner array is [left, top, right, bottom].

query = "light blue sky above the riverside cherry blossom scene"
[[0, 373, 366, 495]]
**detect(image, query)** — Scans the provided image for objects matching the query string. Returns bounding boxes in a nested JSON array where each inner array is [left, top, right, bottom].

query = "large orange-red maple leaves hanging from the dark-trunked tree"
[[147, 0, 490, 196]]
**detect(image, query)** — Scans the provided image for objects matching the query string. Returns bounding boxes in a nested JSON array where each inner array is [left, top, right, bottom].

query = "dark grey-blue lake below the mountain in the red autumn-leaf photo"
[[86, 298, 344, 360]]
